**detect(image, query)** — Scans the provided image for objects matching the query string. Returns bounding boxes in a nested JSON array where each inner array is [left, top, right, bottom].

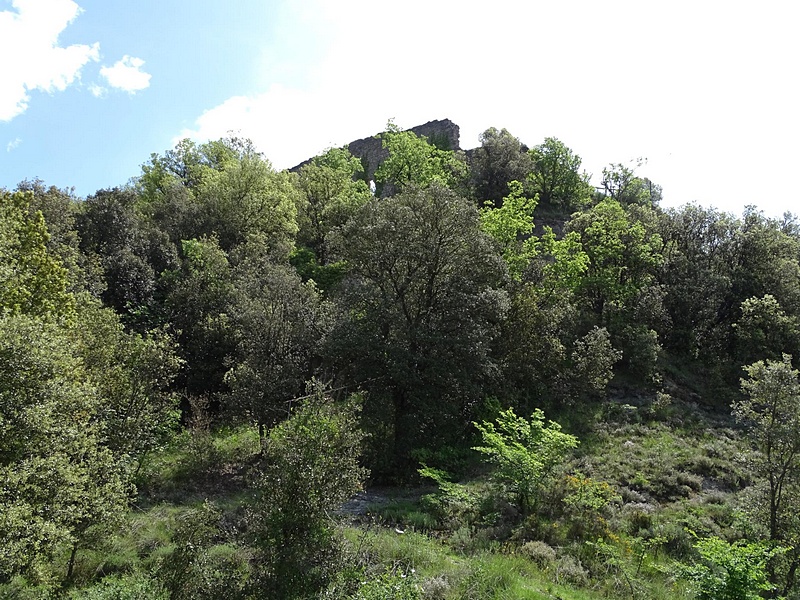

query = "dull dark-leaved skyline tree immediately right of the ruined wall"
[[470, 127, 533, 206]]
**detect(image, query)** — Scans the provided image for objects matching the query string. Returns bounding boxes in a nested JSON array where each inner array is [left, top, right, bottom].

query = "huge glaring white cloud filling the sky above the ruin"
[[182, 0, 800, 214]]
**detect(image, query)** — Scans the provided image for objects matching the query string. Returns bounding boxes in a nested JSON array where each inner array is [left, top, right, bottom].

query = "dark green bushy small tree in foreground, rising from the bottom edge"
[[252, 389, 366, 598]]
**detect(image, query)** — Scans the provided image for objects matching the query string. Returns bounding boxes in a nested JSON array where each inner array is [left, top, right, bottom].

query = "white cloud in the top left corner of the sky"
[[0, 0, 100, 121]]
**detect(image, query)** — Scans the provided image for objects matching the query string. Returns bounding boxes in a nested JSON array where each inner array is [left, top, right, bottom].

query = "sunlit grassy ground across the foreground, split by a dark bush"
[[34, 392, 747, 600]]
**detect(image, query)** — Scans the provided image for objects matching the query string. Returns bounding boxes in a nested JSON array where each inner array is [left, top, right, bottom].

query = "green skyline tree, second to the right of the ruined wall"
[[528, 138, 593, 210]]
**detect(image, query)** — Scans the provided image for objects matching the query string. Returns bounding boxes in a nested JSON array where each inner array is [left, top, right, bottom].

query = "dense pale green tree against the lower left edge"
[[0, 315, 131, 582]]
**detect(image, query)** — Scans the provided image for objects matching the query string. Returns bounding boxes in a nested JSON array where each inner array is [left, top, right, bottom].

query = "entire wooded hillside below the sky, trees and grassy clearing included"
[[0, 122, 800, 600]]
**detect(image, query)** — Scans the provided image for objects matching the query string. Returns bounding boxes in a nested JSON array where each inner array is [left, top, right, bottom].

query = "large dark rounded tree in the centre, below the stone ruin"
[[328, 184, 506, 463]]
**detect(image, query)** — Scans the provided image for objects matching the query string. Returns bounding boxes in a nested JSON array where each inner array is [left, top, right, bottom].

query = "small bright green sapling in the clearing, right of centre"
[[473, 408, 578, 515]]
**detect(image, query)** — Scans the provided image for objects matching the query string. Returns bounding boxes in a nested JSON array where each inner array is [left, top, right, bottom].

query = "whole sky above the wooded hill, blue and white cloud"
[[0, 0, 800, 217]]
